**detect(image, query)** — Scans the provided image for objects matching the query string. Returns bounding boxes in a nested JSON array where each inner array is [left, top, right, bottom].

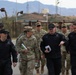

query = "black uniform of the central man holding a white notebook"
[[40, 33, 66, 75]]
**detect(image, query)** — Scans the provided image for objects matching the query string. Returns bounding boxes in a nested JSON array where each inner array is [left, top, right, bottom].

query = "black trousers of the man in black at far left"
[[0, 61, 12, 75]]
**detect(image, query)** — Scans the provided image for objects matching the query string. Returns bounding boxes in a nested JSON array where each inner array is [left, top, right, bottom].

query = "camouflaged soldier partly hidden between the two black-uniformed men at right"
[[61, 26, 70, 75]]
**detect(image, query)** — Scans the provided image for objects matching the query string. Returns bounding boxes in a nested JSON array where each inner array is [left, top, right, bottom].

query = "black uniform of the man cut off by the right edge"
[[68, 32, 76, 75]]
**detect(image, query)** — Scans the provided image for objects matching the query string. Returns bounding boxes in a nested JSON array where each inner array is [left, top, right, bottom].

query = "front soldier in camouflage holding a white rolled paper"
[[16, 27, 38, 75]]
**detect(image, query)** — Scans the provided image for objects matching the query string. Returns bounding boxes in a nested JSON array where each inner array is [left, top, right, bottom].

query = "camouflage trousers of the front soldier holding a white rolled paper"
[[19, 60, 35, 75]]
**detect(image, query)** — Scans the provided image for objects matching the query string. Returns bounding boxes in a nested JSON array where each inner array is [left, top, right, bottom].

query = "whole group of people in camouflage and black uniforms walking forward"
[[0, 22, 76, 75]]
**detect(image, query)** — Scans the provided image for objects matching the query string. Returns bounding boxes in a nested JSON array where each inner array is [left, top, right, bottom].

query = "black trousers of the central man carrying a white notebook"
[[46, 57, 61, 75]]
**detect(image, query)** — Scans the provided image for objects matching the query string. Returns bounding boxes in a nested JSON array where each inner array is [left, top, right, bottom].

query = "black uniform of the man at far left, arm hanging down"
[[0, 40, 17, 75]]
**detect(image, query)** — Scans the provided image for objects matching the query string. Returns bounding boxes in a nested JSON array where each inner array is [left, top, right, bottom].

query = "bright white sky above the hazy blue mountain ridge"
[[5, 0, 76, 8]]
